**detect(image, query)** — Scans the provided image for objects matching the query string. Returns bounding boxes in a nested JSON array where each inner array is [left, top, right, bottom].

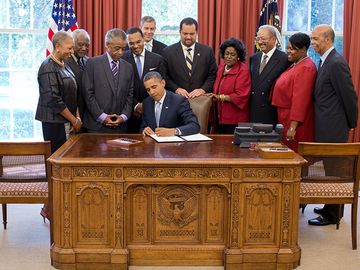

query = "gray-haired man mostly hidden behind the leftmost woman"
[[65, 29, 90, 123]]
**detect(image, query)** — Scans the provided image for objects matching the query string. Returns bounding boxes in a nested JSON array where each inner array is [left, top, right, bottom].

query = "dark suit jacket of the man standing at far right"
[[314, 49, 358, 143]]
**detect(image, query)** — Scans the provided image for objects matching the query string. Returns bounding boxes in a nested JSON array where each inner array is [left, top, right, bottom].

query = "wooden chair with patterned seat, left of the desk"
[[0, 141, 51, 229]]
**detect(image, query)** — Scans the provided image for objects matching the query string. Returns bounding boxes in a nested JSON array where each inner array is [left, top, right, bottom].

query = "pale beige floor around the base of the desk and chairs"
[[0, 202, 360, 270]]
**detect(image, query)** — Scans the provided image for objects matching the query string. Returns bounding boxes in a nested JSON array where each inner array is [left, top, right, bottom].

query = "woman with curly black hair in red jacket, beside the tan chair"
[[211, 38, 251, 134]]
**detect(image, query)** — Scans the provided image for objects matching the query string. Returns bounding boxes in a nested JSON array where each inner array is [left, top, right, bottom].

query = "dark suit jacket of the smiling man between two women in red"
[[250, 49, 291, 125]]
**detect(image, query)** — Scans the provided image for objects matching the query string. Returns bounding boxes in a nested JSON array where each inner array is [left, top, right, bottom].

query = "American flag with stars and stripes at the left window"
[[46, 0, 78, 56]]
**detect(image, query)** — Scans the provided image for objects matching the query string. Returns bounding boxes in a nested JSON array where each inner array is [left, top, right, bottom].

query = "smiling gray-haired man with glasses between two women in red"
[[250, 25, 291, 125]]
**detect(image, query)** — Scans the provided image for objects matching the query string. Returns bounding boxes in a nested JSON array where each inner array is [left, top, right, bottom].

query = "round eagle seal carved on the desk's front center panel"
[[157, 186, 198, 228]]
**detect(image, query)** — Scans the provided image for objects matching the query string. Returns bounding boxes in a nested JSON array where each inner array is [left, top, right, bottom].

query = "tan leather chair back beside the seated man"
[[188, 95, 212, 134]]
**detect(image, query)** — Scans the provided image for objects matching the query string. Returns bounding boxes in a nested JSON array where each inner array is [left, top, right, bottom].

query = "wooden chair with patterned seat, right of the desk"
[[298, 142, 360, 249]]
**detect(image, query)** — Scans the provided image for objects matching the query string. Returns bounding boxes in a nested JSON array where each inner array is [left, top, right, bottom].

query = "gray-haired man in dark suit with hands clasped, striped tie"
[[82, 28, 134, 133]]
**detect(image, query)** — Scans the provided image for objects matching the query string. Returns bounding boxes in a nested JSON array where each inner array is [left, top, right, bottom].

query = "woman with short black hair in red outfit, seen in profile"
[[272, 33, 316, 151]]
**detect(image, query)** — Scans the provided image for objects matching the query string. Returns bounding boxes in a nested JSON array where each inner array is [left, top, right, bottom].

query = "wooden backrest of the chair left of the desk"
[[0, 141, 51, 183]]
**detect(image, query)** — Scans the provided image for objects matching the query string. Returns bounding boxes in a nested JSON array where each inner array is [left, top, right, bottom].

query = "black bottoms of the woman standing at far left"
[[42, 122, 66, 153]]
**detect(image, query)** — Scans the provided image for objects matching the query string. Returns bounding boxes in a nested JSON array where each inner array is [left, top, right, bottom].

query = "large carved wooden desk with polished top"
[[49, 134, 304, 270]]
